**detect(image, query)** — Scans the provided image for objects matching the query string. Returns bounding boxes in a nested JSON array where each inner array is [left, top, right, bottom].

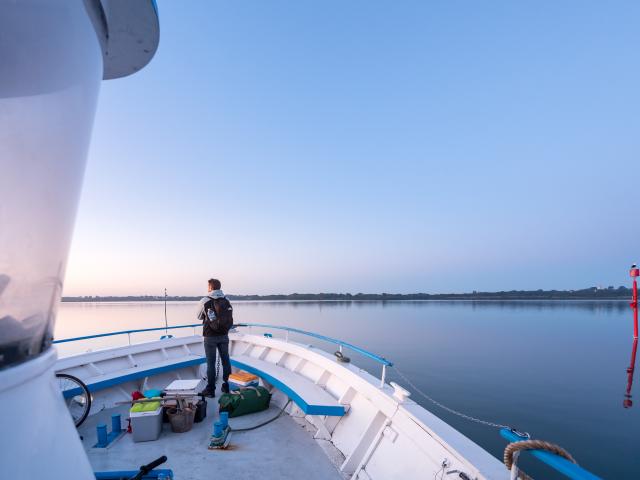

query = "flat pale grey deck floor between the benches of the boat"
[[80, 388, 343, 480]]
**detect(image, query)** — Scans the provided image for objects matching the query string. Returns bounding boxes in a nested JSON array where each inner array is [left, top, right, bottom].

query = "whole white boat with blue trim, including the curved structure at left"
[[0, 0, 598, 480]]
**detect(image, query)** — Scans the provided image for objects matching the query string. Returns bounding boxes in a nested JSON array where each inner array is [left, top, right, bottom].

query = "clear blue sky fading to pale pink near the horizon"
[[64, 0, 640, 295]]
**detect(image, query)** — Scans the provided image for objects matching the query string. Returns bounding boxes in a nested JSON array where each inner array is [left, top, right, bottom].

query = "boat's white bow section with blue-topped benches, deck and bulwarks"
[[43, 323, 598, 479]]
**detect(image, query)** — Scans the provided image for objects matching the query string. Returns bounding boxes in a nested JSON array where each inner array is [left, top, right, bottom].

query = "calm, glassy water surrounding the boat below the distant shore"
[[56, 301, 640, 479]]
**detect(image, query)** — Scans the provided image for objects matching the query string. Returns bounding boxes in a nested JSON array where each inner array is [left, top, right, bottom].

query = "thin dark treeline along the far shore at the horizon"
[[62, 287, 631, 302]]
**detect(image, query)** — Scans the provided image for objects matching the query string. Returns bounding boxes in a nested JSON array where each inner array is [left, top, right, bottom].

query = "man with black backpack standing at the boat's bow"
[[198, 278, 233, 397]]
